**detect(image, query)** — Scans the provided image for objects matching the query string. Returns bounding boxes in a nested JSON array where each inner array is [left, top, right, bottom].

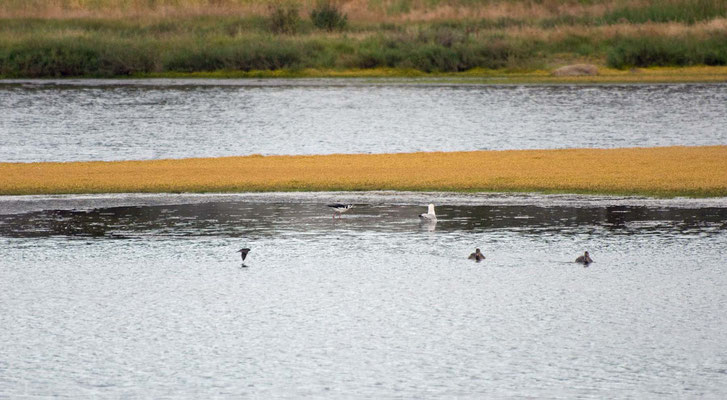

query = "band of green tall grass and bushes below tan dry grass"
[[5, 29, 727, 78]]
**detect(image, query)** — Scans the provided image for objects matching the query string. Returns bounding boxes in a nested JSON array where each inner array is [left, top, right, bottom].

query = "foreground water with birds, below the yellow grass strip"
[[0, 193, 727, 398]]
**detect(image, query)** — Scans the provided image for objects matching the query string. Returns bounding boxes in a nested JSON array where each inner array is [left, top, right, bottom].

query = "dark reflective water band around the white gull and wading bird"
[[0, 196, 727, 238]]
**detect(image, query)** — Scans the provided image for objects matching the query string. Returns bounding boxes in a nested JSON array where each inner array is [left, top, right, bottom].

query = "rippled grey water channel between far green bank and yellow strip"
[[0, 80, 727, 162]]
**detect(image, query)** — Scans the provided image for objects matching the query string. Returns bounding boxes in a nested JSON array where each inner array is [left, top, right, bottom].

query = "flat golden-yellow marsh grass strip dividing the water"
[[0, 146, 727, 197]]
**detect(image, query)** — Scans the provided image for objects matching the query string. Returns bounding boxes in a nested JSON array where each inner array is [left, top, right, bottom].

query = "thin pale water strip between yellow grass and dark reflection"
[[0, 191, 727, 215]]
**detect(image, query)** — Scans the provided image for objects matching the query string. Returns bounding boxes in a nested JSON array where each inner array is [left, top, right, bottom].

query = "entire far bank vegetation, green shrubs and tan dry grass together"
[[0, 0, 727, 77]]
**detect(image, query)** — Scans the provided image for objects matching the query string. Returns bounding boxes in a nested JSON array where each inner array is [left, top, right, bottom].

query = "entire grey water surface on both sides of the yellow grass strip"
[[0, 80, 727, 399]]
